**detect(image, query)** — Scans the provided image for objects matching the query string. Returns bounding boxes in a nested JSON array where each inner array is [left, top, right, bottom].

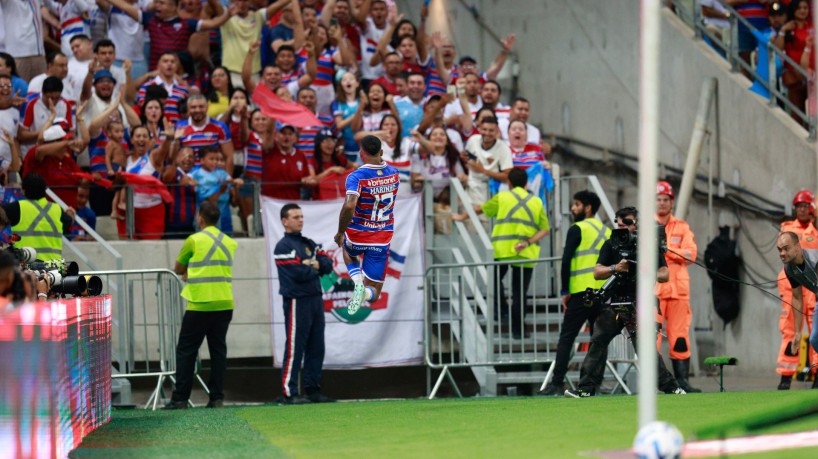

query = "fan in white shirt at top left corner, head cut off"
[[0, 0, 45, 81]]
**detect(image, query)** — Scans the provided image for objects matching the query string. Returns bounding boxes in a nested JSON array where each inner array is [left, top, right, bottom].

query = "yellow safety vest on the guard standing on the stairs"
[[491, 187, 548, 260]]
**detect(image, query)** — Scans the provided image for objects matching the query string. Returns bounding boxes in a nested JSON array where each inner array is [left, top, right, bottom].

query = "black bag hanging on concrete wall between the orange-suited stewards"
[[704, 226, 741, 327]]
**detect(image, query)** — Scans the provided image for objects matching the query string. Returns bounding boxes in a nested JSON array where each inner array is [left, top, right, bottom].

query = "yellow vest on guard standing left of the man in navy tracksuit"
[[182, 226, 238, 303]]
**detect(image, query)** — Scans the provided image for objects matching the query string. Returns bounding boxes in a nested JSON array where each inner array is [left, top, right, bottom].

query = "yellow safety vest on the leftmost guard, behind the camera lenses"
[[11, 198, 63, 261]]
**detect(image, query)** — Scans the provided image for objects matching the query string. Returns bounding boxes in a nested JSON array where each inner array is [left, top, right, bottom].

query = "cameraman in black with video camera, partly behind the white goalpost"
[[565, 207, 685, 398]]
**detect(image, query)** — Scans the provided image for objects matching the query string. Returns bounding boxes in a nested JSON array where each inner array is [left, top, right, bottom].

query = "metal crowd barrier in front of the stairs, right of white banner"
[[424, 255, 562, 398]]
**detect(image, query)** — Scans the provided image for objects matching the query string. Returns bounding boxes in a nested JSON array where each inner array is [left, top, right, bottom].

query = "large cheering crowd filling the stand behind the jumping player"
[[0, 0, 550, 239]]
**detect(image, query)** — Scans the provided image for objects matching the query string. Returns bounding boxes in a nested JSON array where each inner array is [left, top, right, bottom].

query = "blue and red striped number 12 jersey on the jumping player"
[[346, 163, 400, 245]]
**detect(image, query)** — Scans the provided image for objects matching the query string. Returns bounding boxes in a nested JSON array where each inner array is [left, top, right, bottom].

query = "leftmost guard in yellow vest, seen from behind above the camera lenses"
[[3, 173, 74, 261]]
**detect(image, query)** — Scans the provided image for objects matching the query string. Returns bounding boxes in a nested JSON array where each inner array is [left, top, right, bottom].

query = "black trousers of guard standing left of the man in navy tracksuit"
[[171, 309, 233, 402]]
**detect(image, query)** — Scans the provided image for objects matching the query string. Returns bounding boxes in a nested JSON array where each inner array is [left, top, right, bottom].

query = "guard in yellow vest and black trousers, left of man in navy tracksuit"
[[165, 201, 238, 410]]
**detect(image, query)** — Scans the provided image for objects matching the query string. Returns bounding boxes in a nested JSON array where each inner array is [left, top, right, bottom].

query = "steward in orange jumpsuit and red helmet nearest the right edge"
[[775, 190, 818, 390]]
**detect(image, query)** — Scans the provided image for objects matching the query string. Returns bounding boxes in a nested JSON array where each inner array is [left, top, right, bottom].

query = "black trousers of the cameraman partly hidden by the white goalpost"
[[579, 306, 678, 393]]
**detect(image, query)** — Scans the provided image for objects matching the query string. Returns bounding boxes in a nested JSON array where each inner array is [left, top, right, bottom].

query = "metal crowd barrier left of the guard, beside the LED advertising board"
[[80, 269, 208, 410]]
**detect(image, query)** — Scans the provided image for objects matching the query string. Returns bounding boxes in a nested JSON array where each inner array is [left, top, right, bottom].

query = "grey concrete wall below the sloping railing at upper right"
[[398, 0, 816, 373]]
